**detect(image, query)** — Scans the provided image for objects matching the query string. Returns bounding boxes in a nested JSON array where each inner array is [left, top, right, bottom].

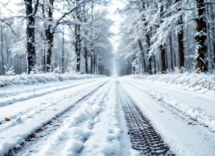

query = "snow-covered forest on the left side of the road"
[[0, 0, 113, 75]]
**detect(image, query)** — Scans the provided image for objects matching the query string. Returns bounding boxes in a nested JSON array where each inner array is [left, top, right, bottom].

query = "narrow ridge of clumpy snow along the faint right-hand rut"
[[129, 83, 215, 131]]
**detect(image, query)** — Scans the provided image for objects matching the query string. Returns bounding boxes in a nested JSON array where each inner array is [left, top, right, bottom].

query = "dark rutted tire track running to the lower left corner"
[[4, 81, 109, 156]]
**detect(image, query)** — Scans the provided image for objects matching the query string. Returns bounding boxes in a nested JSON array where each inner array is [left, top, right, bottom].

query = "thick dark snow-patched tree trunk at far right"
[[195, 0, 208, 72]]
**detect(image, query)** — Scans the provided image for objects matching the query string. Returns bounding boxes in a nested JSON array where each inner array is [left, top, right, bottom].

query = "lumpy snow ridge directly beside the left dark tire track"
[[39, 80, 110, 156]]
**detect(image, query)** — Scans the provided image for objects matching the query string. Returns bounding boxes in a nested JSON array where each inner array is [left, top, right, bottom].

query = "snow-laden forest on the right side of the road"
[[116, 0, 215, 75]]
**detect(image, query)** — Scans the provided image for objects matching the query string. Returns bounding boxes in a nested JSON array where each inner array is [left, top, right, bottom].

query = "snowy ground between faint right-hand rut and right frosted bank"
[[125, 75, 215, 131]]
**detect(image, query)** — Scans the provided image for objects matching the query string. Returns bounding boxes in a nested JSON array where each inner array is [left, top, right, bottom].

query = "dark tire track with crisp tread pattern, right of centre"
[[118, 84, 174, 155]]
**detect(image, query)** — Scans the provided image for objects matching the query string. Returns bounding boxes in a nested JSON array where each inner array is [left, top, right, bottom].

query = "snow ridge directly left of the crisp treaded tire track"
[[81, 81, 121, 156]]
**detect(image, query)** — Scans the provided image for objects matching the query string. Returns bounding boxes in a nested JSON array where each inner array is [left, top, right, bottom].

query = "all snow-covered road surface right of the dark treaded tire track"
[[120, 78, 215, 156]]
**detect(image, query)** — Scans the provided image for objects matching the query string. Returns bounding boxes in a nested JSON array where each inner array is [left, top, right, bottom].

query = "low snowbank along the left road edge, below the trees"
[[0, 73, 105, 87]]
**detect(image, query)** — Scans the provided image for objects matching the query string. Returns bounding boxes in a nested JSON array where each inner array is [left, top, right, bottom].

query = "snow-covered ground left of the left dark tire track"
[[0, 78, 109, 155]]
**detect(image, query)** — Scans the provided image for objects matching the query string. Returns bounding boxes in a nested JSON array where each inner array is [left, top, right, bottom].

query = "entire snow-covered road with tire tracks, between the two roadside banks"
[[0, 78, 215, 156]]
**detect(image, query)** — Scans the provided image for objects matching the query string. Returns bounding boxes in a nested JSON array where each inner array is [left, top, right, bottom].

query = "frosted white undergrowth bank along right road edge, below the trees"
[[129, 73, 215, 91]]
